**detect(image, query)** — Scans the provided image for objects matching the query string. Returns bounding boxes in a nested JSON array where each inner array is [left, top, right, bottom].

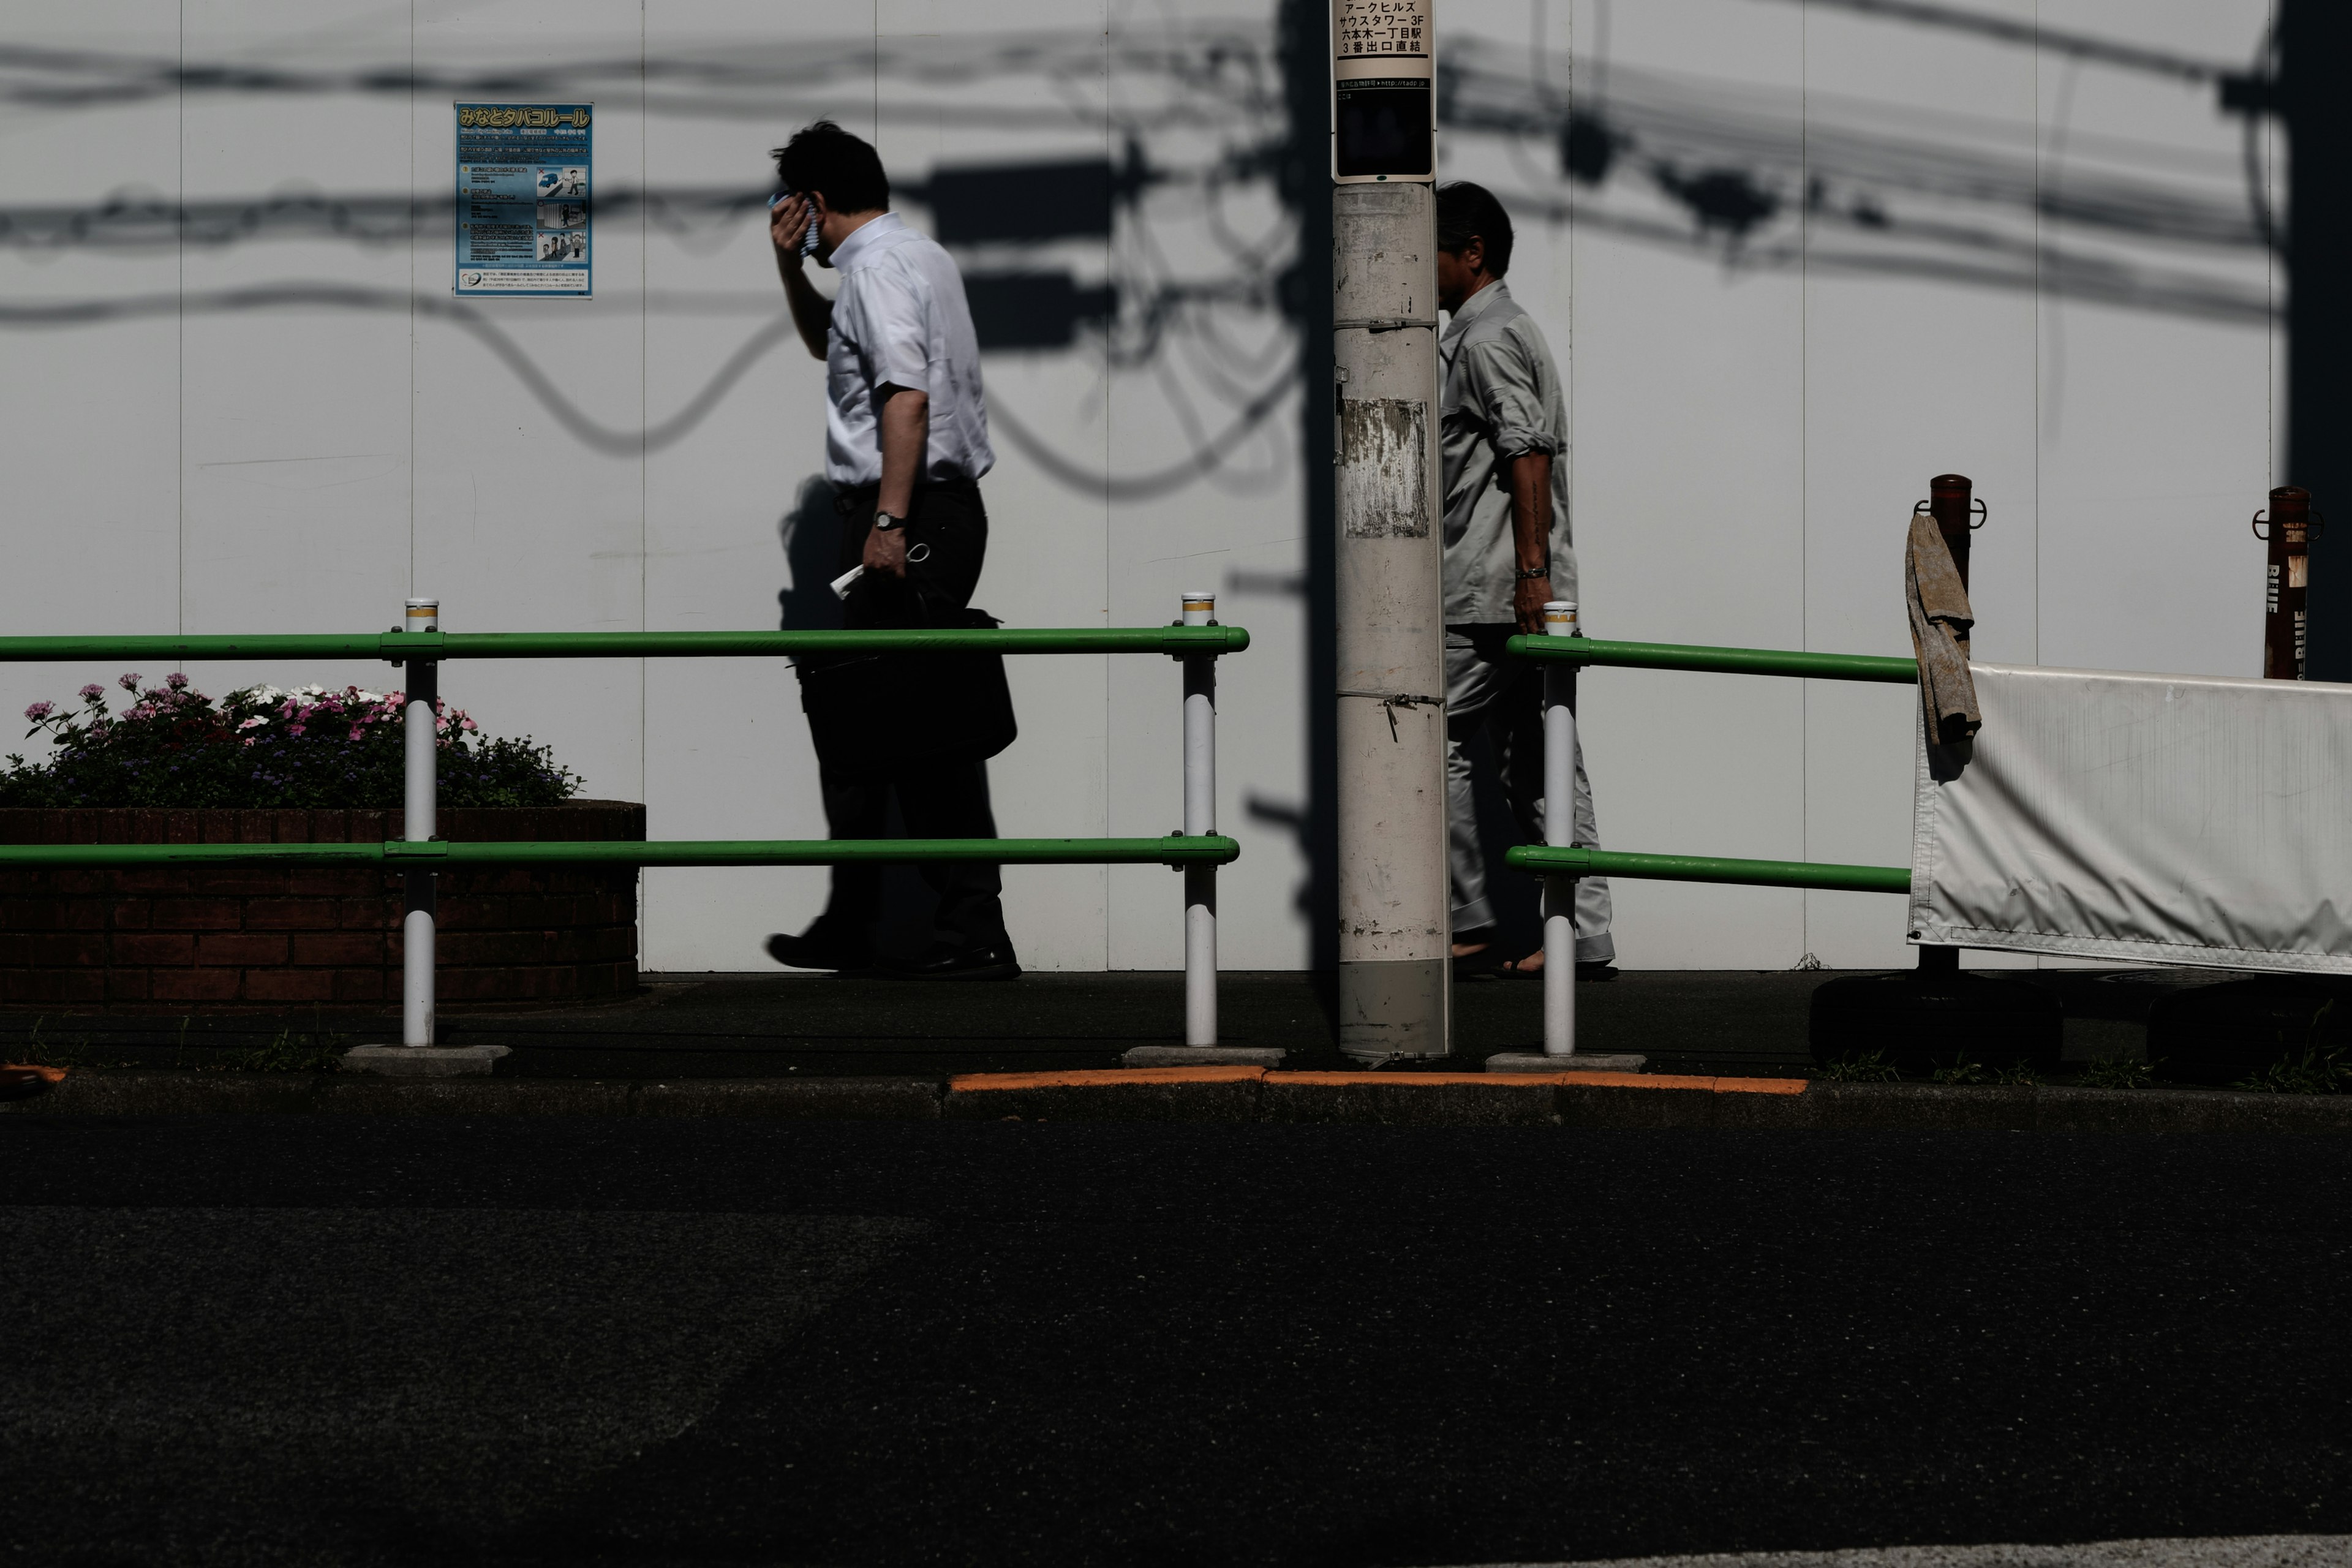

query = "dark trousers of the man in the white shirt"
[[816, 482, 1011, 948]]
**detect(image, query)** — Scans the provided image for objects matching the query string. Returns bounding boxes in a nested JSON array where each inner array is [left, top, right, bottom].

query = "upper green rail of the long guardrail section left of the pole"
[[0, 625, 1249, 663]]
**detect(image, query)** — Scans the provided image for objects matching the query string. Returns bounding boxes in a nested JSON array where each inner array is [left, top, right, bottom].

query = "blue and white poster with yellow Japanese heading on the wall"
[[456, 104, 595, 298]]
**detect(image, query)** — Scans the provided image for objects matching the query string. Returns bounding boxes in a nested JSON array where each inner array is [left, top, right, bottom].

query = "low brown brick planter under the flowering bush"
[[0, 799, 644, 1013]]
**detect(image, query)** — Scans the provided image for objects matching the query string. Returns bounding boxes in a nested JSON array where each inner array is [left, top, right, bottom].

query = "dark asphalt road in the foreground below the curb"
[[0, 1117, 2352, 1566]]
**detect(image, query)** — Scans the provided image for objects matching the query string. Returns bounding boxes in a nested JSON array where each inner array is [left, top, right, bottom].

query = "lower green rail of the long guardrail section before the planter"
[[0, 832, 1242, 872]]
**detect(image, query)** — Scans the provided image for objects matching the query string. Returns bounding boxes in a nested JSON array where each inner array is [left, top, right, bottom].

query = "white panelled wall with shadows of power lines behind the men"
[[0, 0, 2277, 968]]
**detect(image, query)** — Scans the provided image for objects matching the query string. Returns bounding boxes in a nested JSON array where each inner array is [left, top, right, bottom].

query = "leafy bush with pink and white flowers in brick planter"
[[0, 675, 581, 811]]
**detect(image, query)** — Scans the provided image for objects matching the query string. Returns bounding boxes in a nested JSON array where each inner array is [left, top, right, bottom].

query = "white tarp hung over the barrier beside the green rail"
[[1910, 665, 2352, 973]]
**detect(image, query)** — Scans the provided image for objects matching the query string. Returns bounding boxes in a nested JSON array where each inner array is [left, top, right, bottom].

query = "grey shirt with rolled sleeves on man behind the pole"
[[1437, 280, 1576, 625]]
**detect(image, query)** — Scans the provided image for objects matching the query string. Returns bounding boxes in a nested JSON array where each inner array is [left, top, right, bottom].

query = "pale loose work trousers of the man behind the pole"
[[1447, 625, 1616, 964]]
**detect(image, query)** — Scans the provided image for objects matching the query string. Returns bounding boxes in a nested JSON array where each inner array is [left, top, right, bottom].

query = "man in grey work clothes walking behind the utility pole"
[[1437, 181, 1616, 980]]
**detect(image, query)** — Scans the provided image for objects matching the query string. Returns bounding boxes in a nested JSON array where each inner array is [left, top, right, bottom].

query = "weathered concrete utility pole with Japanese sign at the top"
[[1331, 0, 1451, 1063]]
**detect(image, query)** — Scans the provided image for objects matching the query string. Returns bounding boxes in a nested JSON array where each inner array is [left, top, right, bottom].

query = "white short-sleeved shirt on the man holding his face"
[[826, 211, 997, 486]]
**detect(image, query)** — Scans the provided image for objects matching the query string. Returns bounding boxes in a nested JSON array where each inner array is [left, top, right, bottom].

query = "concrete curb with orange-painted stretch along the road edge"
[[13, 1067, 2352, 1136]]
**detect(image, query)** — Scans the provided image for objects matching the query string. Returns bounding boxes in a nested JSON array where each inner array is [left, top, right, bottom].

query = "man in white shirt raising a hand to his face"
[[767, 120, 1021, 980]]
